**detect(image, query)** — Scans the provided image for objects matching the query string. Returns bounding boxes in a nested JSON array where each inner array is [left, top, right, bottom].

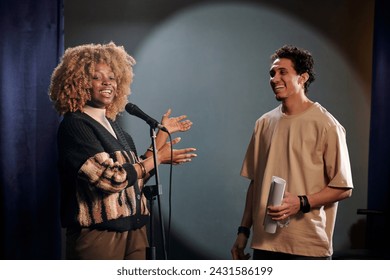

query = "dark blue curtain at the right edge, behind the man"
[[368, 0, 390, 256]]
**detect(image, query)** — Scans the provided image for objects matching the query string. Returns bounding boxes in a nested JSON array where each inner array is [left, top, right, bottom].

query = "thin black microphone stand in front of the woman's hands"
[[143, 125, 167, 260]]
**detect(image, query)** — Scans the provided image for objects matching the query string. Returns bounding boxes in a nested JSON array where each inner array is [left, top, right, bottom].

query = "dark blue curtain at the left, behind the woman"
[[0, 0, 63, 260]]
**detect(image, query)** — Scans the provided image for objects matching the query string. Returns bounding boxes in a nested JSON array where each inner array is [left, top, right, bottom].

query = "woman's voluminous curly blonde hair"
[[49, 42, 135, 120]]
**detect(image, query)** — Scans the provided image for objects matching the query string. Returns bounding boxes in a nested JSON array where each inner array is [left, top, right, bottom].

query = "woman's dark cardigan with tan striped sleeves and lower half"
[[57, 112, 149, 232]]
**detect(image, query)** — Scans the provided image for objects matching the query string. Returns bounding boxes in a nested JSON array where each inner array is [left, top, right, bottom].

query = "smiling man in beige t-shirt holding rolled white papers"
[[231, 46, 353, 259]]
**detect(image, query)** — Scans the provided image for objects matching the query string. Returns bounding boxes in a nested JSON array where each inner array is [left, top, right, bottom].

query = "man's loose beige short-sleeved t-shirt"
[[241, 103, 353, 257]]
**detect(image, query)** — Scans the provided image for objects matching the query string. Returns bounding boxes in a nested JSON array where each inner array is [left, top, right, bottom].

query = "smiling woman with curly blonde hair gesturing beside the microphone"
[[49, 42, 196, 259]]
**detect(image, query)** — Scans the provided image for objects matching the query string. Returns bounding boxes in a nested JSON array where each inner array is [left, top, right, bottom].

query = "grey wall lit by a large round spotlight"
[[65, 0, 374, 259]]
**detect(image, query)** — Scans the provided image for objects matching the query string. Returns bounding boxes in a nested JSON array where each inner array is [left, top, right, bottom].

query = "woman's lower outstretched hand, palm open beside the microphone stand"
[[158, 137, 197, 165]]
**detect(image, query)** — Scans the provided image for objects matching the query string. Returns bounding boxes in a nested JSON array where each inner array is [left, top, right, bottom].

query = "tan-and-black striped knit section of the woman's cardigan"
[[76, 152, 149, 227]]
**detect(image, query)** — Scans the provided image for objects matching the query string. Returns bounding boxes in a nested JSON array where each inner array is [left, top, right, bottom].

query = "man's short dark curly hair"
[[271, 45, 316, 94]]
